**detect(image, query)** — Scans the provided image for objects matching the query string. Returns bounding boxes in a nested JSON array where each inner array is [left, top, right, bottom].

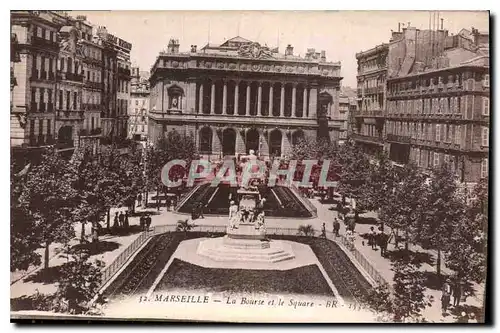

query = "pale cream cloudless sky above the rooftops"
[[70, 11, 489, 88]]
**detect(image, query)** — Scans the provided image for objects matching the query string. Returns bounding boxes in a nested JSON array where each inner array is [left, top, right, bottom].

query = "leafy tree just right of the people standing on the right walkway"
[[380, 163, 427, 250]]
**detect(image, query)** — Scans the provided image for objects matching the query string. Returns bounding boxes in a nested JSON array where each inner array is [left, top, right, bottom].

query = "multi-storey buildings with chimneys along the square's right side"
[[351, 21, 490, 184]]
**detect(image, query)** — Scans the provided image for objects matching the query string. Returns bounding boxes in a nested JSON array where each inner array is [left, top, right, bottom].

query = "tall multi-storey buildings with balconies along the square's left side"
[[10, 11, 132, 161]]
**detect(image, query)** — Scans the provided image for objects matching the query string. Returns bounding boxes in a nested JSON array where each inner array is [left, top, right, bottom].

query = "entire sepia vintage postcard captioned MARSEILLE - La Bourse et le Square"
[[10, 10, 491, 324]]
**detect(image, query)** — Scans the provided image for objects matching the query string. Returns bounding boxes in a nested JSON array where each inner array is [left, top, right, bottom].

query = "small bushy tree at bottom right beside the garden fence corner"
[[392, 258, 433, 322]]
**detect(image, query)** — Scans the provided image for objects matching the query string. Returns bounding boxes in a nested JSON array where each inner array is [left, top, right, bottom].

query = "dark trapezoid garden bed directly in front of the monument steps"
[[155, 259, 333, 296]]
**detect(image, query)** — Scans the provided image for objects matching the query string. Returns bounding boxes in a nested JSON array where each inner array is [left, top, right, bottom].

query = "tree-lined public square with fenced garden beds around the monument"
[[11, 132, 488, 322]]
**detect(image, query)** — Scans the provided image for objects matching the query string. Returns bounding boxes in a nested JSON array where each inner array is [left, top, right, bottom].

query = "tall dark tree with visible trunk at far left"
[[19, 149, 76, 268]]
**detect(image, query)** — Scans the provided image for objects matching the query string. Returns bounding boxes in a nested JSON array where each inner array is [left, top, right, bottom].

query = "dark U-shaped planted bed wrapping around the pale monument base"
[[105, 232, 372, 302]]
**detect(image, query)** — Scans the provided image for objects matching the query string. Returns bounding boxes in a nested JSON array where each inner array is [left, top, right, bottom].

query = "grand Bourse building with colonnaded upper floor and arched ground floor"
[[148, 37, 347, 158]]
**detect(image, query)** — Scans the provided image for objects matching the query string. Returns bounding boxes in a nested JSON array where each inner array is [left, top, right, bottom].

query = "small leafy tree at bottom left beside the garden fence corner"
[[54, 247, 104, 314]]
